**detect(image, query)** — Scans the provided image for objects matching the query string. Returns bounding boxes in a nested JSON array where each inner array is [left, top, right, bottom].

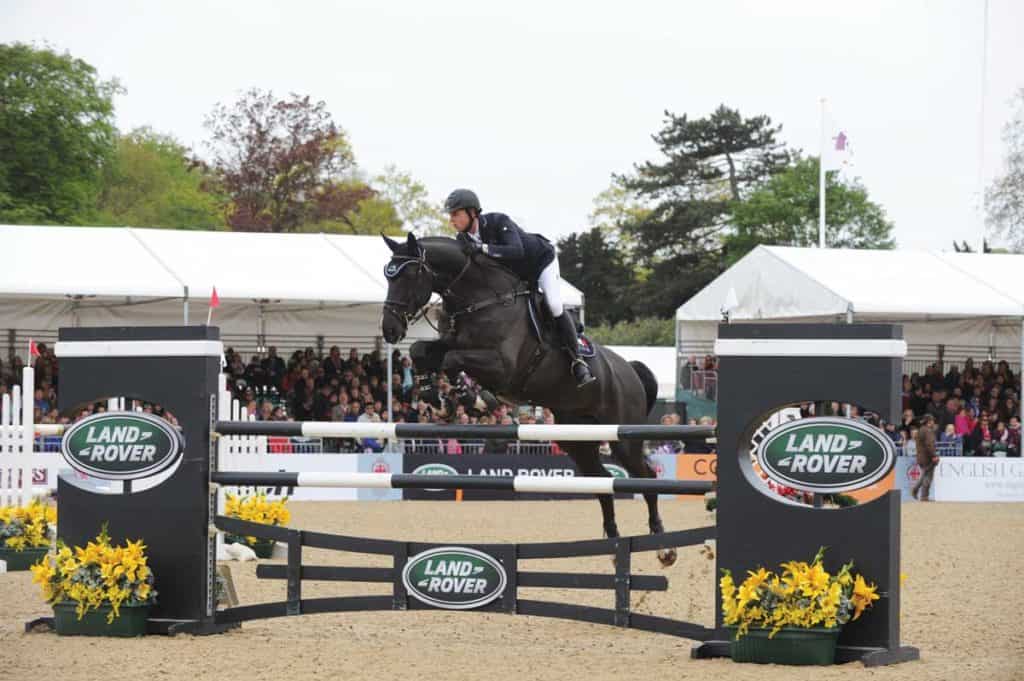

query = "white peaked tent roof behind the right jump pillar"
[[676, 246, 1024, 322]]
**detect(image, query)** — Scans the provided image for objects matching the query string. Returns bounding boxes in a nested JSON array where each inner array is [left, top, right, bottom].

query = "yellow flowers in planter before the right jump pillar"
[[719, 549, 879, 639]]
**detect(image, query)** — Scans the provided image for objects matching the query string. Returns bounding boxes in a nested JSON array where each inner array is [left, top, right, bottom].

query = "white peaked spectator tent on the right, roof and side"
[[676, 246, 1024, 371]]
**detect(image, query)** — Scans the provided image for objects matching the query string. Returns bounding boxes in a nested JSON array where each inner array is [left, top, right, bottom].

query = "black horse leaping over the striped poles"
[[381, 233, 676, 566]]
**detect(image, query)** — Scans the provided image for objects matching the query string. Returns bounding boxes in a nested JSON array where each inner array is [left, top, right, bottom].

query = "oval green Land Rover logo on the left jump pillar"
[[60, 412, 182, 480]]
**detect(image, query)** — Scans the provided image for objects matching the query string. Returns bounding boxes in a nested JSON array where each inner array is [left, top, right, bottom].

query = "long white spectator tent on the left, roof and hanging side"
[[0, 225, 583, 348]]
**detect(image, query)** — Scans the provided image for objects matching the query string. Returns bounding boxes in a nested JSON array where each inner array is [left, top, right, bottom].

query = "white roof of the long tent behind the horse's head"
[[0, 225, 583, 307]]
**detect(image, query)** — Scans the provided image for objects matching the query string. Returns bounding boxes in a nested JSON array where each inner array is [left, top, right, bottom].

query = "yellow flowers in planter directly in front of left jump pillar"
[[32, 527, 157, 623]]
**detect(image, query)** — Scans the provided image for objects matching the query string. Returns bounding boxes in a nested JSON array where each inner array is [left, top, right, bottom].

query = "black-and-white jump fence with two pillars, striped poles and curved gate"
[[39, 324, 918, 665]]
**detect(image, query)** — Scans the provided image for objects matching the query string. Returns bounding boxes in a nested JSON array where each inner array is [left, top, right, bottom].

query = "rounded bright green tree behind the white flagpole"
[[724, 158, 895, 265]]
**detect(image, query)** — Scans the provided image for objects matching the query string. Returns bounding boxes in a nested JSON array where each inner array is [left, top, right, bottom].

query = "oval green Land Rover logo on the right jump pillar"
[[757, 417, 896, 494]]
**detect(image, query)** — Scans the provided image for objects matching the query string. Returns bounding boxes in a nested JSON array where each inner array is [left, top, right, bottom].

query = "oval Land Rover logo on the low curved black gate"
[[401, 546, 508, 610]]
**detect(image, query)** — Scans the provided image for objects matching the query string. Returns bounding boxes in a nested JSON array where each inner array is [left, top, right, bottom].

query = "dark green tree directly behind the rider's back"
[[558, 227, 633, 325]]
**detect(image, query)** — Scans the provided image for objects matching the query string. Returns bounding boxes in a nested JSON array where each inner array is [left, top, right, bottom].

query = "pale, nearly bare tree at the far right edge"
[[985, 88, 1024, 252]]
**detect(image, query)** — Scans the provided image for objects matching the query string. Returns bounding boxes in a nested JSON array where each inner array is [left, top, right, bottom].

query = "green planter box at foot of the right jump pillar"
[[728, 627, 840, 665]]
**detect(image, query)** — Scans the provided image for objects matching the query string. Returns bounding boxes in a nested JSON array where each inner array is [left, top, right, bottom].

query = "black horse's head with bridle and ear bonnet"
[[381, 232, 433, 343]]
